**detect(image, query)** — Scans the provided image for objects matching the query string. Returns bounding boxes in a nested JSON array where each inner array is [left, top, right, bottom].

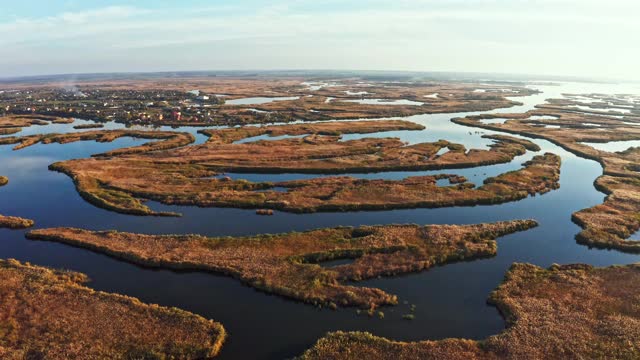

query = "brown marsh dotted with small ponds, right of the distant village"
[[200, 81, 533, 124]]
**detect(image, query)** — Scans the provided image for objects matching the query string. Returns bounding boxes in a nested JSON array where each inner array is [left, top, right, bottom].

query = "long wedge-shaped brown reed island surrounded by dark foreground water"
[[27, 220, 536, 308]]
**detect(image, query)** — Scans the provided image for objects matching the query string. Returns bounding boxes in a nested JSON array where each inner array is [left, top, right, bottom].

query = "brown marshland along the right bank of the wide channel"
[[453, 102, 640, 252]]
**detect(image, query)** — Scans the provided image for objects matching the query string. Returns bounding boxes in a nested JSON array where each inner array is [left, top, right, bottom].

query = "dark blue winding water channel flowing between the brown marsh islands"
[[0, 84, 639, 359]]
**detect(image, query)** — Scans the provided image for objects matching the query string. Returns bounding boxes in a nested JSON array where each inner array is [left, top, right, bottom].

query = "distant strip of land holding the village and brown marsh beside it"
[[0, 77, 536, 126]]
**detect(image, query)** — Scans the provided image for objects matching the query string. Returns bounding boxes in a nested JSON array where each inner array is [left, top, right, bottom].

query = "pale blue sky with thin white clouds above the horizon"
[[0, 0, 640, 80]]
